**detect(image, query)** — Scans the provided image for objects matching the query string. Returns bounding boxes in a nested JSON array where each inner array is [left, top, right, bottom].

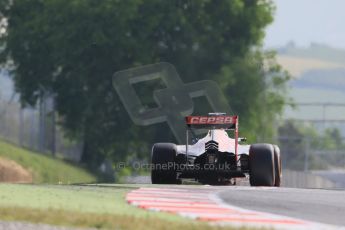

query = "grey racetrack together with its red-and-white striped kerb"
[[126, 185, 345, 229]]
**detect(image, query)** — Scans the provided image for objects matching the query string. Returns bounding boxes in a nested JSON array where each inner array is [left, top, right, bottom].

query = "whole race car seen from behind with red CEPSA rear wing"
[[151, 113, 282, 187]]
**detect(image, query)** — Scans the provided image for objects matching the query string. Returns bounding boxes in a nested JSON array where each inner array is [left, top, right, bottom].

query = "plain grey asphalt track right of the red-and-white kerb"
[[218, 187, 345, 226]]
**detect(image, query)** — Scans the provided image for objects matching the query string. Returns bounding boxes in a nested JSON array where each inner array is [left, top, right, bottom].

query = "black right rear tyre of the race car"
[[249, 144, 275, 186]]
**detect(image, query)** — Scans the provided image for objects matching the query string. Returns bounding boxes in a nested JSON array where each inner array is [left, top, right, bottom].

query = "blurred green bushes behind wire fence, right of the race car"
[[278, 120, 345, 171]]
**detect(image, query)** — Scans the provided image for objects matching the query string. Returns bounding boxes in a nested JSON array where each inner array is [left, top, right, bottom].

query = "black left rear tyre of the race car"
[[151, 143, 181, 184]]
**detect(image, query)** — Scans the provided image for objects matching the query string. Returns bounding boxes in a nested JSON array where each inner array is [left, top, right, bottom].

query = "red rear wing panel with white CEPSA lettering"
[[186, 116, 238, 130]]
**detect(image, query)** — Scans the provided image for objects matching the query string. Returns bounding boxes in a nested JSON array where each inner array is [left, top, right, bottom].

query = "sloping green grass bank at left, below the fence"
[[0, 140, 97, 184]]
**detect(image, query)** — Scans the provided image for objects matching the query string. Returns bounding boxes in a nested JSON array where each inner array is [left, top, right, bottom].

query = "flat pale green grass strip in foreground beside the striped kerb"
[[0, 184, 239, 230]]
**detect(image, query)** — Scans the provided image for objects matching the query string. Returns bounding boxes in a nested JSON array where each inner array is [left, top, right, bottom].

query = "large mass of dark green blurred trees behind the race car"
[[0, 0, 289, 171]]
